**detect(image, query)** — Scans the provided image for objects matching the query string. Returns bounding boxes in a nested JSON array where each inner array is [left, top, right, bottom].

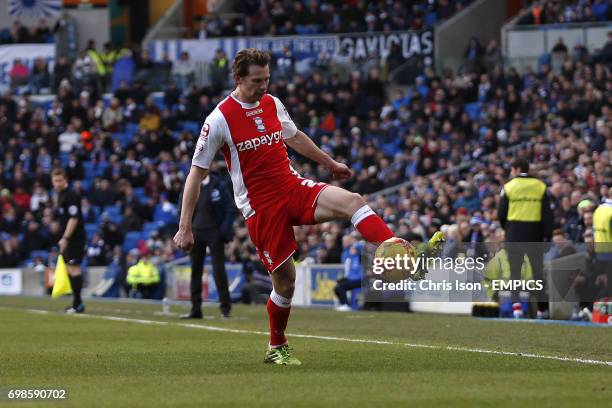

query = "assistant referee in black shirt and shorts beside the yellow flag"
[[51, 168, 87, 313]]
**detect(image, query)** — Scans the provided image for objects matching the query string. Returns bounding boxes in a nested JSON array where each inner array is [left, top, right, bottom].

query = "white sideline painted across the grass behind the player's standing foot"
[[0, 307, 612, 367]]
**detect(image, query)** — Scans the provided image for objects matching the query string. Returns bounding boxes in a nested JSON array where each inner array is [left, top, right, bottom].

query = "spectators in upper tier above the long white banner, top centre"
[[195, 0, 471, 38]]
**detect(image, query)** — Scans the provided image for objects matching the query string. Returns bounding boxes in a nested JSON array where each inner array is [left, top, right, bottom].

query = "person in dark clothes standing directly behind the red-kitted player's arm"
[[178, 173, 236, 319]]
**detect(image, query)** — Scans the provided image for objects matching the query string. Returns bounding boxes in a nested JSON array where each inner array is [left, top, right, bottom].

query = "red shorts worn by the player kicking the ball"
[[246, 178, 327, 273]]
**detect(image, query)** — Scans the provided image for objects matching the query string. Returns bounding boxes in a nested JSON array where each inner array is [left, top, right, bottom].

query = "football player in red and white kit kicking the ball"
[[174, 48, 393, 365]]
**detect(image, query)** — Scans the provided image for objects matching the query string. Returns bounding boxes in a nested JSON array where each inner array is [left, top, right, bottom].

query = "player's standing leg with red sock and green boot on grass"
[[264, 257, 302, 365]]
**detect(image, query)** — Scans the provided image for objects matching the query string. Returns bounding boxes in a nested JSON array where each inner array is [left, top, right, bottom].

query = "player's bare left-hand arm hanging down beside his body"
[[174, 166, 208, 251]]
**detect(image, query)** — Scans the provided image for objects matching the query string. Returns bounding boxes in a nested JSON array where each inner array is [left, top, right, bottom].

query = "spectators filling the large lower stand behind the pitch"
[[0, 19, 612, 300]]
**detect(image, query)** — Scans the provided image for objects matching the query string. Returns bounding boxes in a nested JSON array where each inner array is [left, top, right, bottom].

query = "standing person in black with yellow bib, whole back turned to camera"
[[497, 158, 553, 317]]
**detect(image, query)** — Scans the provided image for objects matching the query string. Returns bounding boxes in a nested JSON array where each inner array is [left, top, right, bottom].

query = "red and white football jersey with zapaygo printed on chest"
[[192, 94, 299, 218]]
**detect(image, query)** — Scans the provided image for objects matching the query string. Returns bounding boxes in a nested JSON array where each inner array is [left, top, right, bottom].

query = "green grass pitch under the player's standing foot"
[[0, 297, 612, 407]]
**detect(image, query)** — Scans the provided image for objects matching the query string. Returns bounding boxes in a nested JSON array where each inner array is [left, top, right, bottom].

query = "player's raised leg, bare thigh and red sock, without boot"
[[314, 186, 394, 244]]
